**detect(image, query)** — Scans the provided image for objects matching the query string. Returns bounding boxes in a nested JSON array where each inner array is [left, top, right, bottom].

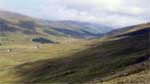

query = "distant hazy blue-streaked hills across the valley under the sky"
[[0, 11, 111, 43]]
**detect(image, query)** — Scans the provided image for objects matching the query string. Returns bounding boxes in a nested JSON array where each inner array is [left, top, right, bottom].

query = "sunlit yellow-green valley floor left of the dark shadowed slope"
[[0, 39, 90, 83]]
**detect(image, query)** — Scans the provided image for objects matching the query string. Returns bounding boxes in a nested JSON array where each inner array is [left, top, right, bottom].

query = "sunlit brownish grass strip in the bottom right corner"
[[102, 70, 150, 84]]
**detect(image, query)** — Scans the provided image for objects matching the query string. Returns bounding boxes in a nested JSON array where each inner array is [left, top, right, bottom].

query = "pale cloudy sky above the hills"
[[0, 0, 150, 27]]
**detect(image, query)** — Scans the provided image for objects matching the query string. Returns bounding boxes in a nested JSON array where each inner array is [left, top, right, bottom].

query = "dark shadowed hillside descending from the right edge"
[[16, 24, 150, 84]]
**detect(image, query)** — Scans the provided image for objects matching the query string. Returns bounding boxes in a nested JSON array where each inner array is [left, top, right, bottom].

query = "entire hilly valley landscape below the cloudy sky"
[[0, 11, 150, 84]]
